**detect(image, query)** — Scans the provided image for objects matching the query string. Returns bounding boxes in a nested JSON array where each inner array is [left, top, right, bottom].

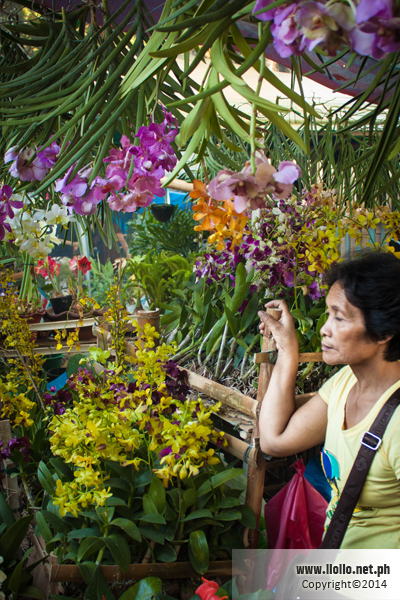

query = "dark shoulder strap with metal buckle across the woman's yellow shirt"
[[320, 389, 400, 549]]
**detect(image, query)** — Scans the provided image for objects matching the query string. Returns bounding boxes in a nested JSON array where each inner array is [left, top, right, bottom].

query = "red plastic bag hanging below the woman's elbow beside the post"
[[264, 459, 328, 589]]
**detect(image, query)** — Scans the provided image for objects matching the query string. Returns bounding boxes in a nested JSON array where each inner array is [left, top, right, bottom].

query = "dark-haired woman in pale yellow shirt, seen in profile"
[[259, 252, 400, 548]]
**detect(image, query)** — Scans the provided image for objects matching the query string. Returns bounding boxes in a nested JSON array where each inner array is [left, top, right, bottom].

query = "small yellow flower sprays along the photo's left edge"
[[0, 274, 44, 427]]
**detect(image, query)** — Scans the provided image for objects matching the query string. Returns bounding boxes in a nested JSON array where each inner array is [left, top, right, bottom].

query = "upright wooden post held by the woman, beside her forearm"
[[245, 308, 281, 549]]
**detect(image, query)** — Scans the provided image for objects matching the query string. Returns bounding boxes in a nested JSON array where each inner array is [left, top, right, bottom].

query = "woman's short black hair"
[[325, 251, 400, 362]]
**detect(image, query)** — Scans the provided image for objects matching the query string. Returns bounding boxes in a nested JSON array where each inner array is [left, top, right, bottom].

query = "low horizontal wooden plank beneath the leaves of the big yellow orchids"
[[51, 560, 241, 583]]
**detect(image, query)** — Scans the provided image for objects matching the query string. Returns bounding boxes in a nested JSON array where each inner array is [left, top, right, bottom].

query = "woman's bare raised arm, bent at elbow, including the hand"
[[259, 300, 327, 456]]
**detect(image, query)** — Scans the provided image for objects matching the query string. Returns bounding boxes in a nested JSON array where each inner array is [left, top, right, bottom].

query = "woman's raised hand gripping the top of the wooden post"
[[258, 300, 299, 353]]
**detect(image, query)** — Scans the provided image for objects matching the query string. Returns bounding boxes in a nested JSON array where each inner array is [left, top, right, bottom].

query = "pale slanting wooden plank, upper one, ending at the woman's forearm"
[[182, 369, 258, 417]]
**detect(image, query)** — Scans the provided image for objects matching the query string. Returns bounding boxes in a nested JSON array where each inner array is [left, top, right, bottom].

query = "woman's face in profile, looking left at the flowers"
[[321, 282, 386, 365]]
